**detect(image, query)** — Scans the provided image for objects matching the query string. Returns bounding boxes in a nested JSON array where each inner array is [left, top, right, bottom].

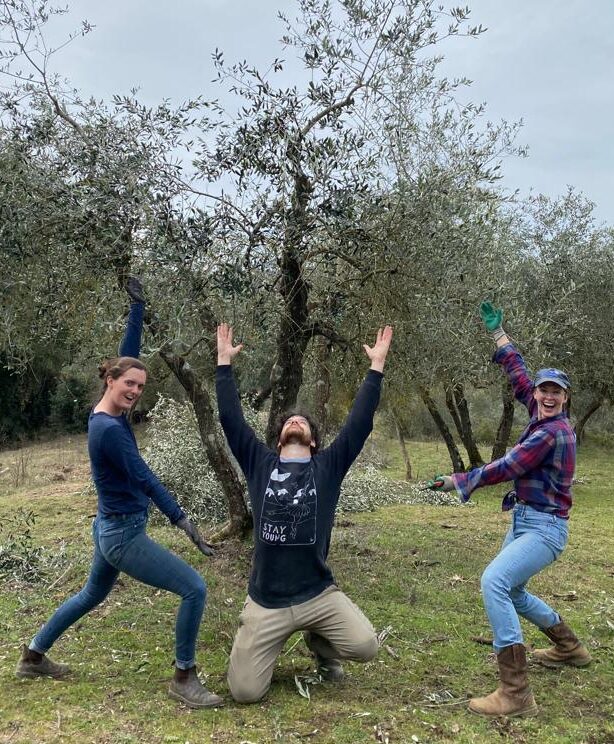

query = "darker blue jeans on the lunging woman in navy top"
[[30, 512, 207, 669]]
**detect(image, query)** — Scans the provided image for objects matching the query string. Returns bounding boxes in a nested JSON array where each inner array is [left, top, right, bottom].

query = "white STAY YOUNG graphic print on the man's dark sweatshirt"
[[259, 464, 317, 547]]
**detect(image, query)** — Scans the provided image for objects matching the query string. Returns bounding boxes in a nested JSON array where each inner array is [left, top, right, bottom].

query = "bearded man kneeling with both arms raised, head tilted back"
[[216, 324, 392, 703]]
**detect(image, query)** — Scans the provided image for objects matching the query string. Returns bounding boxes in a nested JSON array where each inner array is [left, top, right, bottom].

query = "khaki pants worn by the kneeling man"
[[228, 585, 378, 703]]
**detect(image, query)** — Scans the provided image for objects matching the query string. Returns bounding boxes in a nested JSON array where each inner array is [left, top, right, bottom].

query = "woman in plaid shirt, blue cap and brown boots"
[[436, 302, 591, 716]]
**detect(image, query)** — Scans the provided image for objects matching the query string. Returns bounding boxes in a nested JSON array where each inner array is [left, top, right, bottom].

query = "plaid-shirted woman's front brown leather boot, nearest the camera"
[[469, 643, 537, 716]]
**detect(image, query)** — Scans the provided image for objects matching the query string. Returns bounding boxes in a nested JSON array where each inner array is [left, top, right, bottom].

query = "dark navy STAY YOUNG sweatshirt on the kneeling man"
[[216, 365, 383, 608]]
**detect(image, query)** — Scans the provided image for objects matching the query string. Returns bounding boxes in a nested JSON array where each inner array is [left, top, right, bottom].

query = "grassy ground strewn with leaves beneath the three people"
[[0, 437, 614, 744]]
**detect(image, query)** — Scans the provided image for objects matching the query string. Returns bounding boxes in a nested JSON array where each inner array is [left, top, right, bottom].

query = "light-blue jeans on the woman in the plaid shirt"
[[482, 504, 567, 653]]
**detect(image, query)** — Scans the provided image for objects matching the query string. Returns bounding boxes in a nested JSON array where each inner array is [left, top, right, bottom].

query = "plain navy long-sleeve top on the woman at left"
[[87, 302, 185, 524]]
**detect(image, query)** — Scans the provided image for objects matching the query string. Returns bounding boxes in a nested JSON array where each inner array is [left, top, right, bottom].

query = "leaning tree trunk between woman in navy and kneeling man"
[[159, 350, 252, 539]]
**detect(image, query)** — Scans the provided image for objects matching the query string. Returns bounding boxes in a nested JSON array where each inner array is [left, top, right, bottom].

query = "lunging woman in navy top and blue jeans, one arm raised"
[[16, 278, 223, 708]]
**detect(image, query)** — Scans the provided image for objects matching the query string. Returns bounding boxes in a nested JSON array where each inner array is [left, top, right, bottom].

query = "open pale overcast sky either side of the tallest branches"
[[45, 0, 614, 224]]
